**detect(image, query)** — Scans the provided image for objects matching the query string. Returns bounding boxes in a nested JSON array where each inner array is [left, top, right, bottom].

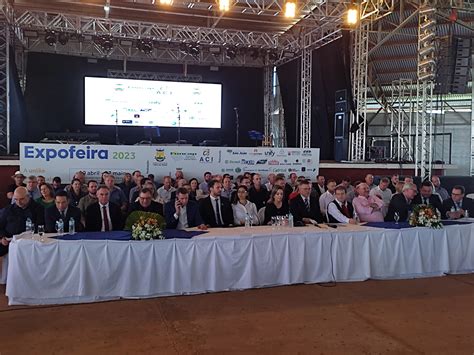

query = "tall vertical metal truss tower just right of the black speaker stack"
[[349, 22, 370, 161]]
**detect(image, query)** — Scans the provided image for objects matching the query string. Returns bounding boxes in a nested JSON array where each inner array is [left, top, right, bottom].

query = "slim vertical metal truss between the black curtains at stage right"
[[300, 44, 313, 148]]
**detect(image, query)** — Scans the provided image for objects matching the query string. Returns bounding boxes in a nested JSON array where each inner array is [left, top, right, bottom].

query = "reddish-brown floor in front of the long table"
[[0, 274, 474, 355]]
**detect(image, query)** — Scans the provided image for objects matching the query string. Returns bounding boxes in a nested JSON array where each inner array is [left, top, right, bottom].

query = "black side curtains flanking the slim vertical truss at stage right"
[[277, 32, 351, 160]]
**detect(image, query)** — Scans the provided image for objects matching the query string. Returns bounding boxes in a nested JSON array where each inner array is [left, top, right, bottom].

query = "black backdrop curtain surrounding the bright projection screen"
[[25, 53, 263, 146]]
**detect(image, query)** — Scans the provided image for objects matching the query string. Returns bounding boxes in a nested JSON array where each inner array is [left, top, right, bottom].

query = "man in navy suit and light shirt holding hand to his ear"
[[165, 187, 207, 229]]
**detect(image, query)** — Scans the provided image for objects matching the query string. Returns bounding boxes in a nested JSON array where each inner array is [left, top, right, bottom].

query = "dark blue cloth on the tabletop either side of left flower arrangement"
[[54, 229, 207, 241]]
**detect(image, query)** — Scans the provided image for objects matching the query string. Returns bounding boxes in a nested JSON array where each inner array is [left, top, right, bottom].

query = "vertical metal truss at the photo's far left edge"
[[0, 14, 10, 154]]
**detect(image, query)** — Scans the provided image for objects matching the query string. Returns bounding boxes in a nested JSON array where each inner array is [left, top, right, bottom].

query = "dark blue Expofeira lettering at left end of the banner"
[[24, 145, 109, 161]]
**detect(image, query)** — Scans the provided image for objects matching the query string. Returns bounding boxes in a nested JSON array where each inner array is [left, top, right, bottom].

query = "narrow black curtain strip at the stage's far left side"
[[8, 48, 27, 154]]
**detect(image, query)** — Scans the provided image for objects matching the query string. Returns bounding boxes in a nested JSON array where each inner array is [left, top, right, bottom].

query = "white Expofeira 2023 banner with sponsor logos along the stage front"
[[20, 143, 319, 182]]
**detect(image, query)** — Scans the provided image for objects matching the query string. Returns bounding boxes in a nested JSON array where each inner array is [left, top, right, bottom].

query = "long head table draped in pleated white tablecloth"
[[6, 223, 474, 305]]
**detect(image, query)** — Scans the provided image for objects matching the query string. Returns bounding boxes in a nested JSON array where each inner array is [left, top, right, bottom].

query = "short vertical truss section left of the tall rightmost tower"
[[390, 79, 414, 161]]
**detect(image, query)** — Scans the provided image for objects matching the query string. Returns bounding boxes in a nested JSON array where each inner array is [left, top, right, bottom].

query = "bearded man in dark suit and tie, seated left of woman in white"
[[199, 180, 234, 227]]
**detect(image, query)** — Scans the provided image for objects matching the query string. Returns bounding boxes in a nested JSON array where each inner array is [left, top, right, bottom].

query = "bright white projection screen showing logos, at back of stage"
[[84, 77, 222, 128]]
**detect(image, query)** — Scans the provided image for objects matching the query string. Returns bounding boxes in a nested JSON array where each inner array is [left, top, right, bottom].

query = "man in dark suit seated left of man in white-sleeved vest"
[[290, 180, 323, 225]]
